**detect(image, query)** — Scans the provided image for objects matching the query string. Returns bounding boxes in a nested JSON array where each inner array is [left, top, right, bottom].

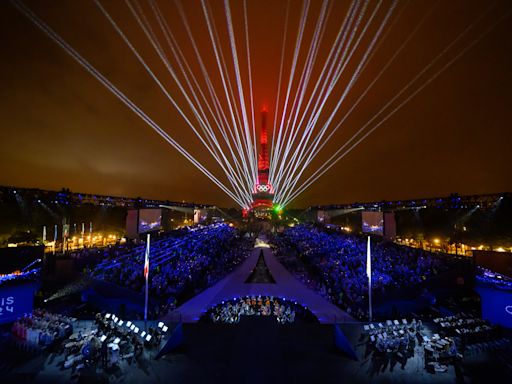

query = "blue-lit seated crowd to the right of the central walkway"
[[274, 225, 454, 318]]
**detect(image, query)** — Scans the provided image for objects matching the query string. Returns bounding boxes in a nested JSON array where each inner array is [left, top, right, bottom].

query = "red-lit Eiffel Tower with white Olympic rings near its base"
[[251, 107, 274, 210]]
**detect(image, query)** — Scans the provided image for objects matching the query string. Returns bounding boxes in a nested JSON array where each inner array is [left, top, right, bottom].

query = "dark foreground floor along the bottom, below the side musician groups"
[[2, 317, 508, 384]]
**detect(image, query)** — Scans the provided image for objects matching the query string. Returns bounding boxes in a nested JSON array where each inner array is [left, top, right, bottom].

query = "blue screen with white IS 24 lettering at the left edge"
[[0, 284, 35, 324]]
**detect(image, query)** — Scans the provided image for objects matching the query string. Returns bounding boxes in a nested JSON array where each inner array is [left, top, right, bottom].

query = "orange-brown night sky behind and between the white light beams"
[[0, 0, 512, 206]]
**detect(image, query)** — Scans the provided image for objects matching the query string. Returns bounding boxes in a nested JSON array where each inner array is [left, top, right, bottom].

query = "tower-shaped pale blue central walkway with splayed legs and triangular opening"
[[166, 239, 355, 324]]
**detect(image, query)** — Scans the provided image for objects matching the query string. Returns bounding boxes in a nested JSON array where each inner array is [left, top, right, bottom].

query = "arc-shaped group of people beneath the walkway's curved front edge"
[[206, 295, 314, 324]]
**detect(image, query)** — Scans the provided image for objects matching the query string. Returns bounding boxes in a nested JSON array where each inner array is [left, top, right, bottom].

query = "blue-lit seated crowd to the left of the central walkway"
[[89, 224, 251, 303]]
